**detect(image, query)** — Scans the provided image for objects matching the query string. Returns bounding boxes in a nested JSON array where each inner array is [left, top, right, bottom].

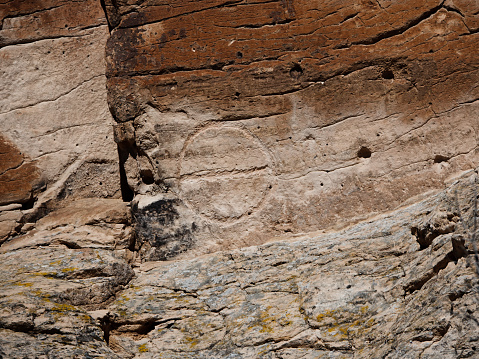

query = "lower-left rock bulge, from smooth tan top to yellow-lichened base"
[[0, 199, 134, 358]]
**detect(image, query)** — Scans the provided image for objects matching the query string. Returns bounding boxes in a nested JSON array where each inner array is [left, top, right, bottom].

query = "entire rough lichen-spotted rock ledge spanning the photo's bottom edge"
[[0, 171, 479, 358]]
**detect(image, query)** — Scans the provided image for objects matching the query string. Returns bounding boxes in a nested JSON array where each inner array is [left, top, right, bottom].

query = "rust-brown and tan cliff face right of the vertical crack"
[[105, 0, 479, 259]]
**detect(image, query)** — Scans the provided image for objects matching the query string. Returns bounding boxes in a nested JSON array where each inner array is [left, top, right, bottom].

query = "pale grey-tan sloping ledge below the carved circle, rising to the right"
[[96, 173, 479, 358]]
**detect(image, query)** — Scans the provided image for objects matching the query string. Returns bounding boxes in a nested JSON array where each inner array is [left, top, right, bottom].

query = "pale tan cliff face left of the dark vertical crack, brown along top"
[[0, 0, 120, 214]]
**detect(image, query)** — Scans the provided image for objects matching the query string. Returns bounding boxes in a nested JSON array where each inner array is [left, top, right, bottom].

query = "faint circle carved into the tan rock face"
[[179, 126, 272, 221]]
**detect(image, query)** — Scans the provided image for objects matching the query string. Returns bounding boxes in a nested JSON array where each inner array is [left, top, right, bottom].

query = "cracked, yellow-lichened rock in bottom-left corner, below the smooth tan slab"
[[0, 246, 133, 358]]
